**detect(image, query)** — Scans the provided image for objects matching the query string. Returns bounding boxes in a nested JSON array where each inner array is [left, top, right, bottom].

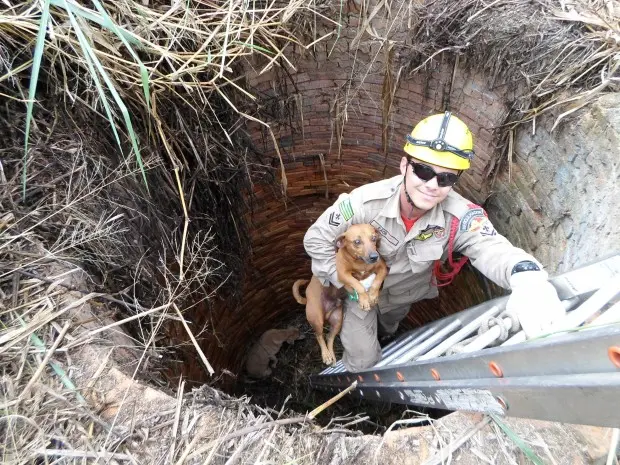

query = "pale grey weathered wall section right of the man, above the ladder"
[[486, 93, 620, 274]]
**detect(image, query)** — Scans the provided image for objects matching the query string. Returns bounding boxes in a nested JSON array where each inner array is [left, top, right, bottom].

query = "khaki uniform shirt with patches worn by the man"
[[304, 176, 542, 313]]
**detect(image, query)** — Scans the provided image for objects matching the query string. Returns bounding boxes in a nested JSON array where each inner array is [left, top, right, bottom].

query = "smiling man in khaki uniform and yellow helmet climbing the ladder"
[[304, 112, 565, 371]]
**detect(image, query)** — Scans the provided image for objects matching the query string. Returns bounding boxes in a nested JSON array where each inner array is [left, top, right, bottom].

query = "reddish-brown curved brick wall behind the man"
[[201, 10, 507, 371]]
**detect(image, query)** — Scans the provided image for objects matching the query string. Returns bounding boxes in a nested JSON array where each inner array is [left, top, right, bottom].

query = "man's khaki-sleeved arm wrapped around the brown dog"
[[304, 189, 364, 288]]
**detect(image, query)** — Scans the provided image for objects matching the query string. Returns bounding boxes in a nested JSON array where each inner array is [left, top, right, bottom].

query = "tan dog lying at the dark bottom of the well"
[[245, 327, 304, 378]]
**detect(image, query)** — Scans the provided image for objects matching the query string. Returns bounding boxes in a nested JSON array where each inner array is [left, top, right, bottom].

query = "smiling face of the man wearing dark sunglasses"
[[400, 157, 458, 211]]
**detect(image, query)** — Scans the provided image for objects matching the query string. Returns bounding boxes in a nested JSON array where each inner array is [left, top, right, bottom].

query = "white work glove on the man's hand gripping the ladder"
[[506, 271, 566, 339]]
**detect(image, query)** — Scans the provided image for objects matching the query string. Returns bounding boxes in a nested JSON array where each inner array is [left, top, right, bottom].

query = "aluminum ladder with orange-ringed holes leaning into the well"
[[310, 252, 620, 427]]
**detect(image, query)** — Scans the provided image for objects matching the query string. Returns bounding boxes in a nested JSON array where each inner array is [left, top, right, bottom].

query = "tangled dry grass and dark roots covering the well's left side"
[[0, 0, 334, 463]]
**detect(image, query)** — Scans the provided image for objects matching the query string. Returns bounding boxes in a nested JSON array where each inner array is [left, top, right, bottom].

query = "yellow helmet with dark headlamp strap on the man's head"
[[404, 111, 474, 170]]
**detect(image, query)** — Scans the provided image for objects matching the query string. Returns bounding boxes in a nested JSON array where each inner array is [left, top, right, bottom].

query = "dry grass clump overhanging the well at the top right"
[[402, 0, 620, 172]]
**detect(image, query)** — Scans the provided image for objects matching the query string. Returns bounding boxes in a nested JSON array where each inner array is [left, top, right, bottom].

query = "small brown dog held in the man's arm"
[[293, 224, 388, 365]]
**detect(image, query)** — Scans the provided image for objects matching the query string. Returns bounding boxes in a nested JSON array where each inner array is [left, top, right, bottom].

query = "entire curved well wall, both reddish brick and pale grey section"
[[161, 10, 620, 382]]
